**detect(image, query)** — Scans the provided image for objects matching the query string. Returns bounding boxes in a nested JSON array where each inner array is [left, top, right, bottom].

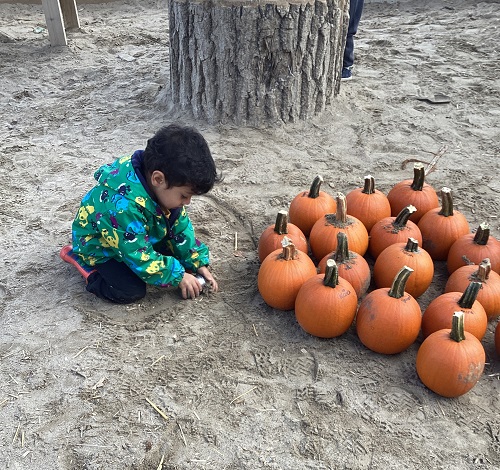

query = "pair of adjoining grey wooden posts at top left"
[[42, 0, 80, 46]]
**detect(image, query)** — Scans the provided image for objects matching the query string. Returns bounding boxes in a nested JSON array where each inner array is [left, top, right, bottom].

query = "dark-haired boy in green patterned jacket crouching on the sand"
[[60, 124, 220, 304]]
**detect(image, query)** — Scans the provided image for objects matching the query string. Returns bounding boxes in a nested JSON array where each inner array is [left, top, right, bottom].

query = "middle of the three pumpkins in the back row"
[[346, 175, 391, 232]]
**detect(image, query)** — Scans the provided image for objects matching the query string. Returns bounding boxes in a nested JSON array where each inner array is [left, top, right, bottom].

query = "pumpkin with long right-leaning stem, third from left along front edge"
[[356, 266, 422, 354]]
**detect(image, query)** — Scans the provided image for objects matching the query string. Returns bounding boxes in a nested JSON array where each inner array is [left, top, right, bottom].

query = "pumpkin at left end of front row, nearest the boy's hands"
[[257, 237, 317, 310]]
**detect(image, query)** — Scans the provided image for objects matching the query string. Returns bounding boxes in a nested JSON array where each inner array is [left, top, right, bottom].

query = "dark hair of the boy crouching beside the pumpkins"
[[143, 124, 221, 194]]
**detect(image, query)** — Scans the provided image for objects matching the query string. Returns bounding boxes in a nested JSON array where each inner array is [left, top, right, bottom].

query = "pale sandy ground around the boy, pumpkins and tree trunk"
[[0, 0, 500, 470]]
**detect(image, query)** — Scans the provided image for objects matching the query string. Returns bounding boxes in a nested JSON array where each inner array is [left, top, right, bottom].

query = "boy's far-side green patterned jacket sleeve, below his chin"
[[156, 208, 210, 272]]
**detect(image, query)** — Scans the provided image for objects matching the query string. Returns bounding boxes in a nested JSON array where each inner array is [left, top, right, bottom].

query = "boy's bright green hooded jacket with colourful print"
[[72, 150, 209, 286]]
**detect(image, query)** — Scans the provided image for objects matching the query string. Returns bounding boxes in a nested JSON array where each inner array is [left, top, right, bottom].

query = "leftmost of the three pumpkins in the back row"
[[288, 175, 337, 237]]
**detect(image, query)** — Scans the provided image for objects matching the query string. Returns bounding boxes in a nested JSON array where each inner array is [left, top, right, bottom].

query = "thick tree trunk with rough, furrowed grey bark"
[[169, 0, 349, 126]]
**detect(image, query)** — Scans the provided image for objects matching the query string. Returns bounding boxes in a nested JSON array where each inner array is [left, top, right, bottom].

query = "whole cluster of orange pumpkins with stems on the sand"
[[258, 167, 500, 397]]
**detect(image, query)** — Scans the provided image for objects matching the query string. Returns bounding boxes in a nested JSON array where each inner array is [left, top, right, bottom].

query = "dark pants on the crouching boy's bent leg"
[[87, 259, 146, 304]]
